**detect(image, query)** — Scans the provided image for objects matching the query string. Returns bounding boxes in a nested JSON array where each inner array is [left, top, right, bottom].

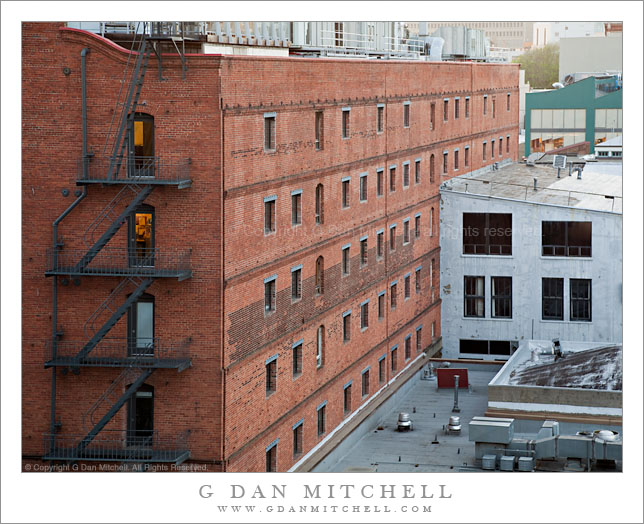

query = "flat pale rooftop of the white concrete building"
[[441, 163, 622, 214]]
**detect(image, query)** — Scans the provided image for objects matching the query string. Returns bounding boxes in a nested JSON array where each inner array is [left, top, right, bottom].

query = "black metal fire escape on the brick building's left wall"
[[43, 27, 192, 463]]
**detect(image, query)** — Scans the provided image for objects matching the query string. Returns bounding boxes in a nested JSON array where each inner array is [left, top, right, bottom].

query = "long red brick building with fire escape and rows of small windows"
[[22, 23, 519, 471]]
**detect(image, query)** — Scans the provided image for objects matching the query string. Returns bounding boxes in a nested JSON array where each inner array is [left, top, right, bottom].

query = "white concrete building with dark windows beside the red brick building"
[[440, 162, 622, 360]]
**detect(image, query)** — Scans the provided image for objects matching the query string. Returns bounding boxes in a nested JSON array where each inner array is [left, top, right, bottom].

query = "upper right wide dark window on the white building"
[[541, 221, 592, 257]]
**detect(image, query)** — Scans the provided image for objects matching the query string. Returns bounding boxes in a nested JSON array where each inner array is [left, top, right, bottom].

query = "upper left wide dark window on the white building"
[[463, 213, 512, 255]]
